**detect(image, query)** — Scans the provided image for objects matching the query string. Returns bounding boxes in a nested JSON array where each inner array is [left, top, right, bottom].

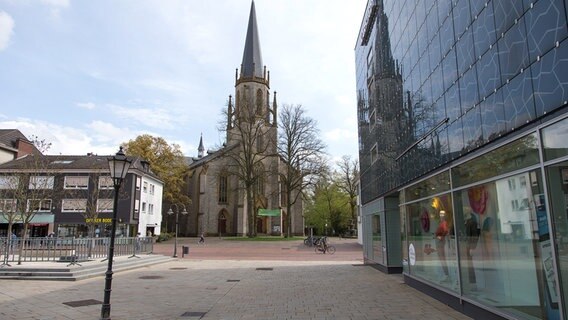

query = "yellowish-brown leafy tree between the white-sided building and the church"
[[124, 134, 191, 204]]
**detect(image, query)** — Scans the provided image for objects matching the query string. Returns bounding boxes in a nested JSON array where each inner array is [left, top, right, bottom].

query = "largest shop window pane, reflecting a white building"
[[454, 171, 559, 319]]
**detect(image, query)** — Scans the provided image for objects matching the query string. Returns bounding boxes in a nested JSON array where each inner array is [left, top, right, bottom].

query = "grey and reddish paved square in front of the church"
[[0, 239, 469, 320]]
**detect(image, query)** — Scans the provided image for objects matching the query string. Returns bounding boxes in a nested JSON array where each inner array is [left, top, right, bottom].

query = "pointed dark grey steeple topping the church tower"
[[241, 0, 264, 78]]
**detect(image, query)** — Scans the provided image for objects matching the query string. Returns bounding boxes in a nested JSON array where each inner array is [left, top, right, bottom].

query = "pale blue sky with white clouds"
[[0, 0, 367, 160]]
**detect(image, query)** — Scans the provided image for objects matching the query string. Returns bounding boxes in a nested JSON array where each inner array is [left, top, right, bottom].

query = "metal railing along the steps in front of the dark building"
[[0, 237, 154, 265]]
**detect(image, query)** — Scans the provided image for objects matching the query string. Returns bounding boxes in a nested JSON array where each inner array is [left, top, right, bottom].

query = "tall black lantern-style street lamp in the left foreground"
[[101, 147, 132, 320]]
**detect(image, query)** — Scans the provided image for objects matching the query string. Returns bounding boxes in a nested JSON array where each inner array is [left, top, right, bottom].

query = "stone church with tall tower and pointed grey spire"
[[179, 1, 304, 236]]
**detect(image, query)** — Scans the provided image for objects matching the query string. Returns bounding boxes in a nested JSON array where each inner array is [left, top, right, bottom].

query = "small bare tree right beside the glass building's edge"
[[336, 155, 359, 232]]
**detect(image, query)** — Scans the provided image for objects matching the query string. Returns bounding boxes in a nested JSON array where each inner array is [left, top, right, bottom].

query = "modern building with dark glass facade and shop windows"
[[355, 0, 568, 319]]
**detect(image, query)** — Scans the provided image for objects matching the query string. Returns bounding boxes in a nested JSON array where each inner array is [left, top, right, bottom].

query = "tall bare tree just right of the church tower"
[[278, 105, 326, 237]]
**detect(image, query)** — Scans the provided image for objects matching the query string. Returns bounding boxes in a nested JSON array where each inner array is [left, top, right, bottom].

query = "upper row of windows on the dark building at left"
[[0, 175, 114, 193]]
